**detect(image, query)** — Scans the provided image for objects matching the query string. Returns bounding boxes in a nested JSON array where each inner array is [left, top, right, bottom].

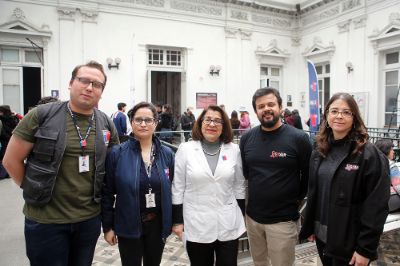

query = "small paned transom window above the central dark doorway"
[[148, 48, 182, 67]]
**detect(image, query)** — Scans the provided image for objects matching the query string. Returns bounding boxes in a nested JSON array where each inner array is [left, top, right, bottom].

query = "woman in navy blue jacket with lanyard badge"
[[102, 102, 174, 266]]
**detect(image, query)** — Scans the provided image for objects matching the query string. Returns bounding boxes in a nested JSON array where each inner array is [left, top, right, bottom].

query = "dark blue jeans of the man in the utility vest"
[[25, 216, 101, 266]]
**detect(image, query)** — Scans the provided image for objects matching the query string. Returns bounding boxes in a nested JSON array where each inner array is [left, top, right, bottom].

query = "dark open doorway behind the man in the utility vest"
[[22, 67, 42, 114]]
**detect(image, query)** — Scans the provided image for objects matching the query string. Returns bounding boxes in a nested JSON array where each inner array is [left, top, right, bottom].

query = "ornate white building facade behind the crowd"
[[0, 0, 400, 127]]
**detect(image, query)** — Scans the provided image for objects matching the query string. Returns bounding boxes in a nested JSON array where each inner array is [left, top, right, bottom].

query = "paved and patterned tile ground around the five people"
[[0, 179, 400, 266]]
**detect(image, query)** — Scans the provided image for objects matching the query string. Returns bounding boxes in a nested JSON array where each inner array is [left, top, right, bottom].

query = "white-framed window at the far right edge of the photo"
[[383, 50, 400, 127]]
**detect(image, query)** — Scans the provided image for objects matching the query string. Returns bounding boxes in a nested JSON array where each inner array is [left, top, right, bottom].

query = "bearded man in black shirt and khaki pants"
[[240, 88, 312, 266]]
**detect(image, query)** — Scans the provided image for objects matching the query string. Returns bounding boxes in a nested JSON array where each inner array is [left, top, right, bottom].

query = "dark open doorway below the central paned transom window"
[[151, 71, 181, 118]]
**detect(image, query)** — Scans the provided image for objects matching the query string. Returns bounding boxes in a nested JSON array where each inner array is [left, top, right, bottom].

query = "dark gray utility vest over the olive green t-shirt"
[[21, 102, 114, 206]]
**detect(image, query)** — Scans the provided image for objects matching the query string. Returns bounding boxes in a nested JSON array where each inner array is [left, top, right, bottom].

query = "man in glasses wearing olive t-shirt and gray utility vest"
[[3, 61, 118, 266]]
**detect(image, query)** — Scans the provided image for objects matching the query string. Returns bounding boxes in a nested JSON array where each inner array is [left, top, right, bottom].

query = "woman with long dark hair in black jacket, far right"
[[299, 93, 389, 266]]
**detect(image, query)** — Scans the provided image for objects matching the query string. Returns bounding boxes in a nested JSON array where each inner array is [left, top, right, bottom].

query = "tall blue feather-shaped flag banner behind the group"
[[307, 60, 319, 132]]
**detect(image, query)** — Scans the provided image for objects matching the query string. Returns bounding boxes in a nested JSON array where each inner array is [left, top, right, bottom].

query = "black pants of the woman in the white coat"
[[186, 239, 239, 266]]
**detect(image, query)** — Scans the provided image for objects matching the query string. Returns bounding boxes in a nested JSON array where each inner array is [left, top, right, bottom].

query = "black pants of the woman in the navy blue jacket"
[[118, 216, 165, 266]]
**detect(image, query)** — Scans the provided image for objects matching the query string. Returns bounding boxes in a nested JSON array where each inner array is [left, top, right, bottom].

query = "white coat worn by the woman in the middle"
[[172, 141, 246, 243]]
